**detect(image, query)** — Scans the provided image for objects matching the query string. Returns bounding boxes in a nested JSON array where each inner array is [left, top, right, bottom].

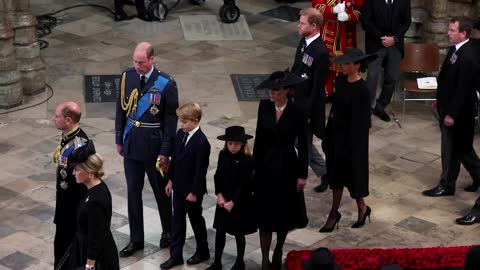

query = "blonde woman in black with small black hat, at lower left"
[[62, 141, 120, 270]]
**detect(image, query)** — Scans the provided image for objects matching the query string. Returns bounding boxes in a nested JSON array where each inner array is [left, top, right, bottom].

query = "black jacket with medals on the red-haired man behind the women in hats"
[[292, 37, 330, 139]]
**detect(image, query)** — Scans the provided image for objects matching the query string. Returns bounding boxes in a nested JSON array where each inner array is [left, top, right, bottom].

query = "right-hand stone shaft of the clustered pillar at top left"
[[13, 0, 47, 95]]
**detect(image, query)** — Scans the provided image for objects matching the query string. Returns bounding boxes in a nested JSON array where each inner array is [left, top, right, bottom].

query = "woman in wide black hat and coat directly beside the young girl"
[[253, 71, 308, 270]]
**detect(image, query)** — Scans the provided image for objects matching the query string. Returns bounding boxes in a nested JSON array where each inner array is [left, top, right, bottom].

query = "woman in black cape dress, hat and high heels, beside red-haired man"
[[320, 48, 374, 232]]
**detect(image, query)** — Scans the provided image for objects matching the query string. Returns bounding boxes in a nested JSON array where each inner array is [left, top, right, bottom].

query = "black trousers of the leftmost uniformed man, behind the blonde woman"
[[53, 223, 76, 269]]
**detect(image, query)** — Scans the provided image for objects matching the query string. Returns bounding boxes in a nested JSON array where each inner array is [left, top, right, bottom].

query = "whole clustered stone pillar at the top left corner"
[[0, 0, 47, 108]]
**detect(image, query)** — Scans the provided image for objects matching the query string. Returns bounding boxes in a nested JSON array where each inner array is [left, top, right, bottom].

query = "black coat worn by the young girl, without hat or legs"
[[213, 150, 257, 235]]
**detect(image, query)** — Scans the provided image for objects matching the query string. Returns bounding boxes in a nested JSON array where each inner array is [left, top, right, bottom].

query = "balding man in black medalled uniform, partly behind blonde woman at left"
[[52, 101, 88, 269]]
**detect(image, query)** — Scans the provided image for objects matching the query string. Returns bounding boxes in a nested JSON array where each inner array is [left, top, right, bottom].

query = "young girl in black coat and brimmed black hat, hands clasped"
[[207, 126, 257, 270]]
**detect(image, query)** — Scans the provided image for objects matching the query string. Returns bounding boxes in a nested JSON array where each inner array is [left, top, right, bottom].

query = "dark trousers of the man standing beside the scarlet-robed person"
[[367, 46, 402, 109]]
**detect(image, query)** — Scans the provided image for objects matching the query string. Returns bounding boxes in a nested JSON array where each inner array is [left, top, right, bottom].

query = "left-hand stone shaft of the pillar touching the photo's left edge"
[[0, 0, 23, 109]]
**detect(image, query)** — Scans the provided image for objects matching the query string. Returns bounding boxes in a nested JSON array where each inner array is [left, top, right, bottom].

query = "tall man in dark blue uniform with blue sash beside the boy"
[[115, 42, 178, 257]]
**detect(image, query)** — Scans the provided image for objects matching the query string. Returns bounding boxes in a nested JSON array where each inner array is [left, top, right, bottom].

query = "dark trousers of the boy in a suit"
[[170, 193, 208, 258]]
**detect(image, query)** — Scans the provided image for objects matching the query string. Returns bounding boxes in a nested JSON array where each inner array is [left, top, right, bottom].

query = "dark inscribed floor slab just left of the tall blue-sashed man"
[[85, 75, 122, 103]]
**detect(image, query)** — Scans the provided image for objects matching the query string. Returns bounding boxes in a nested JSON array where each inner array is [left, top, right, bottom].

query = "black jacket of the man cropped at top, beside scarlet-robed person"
[[360, 0, 412, 57]]
